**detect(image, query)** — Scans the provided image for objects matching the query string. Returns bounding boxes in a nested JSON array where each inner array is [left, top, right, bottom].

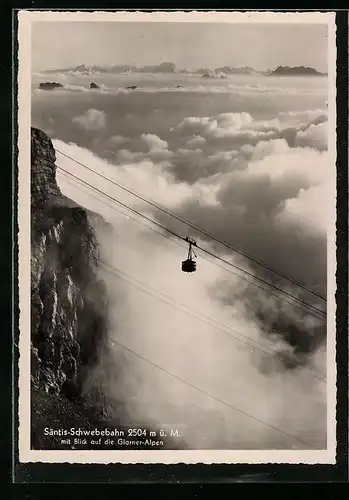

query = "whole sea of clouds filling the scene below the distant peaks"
[[33, 73, 335, 449]]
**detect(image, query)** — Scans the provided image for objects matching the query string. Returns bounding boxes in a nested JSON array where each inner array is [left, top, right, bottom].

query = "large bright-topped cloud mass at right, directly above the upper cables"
[[166, 140, 331, 293]]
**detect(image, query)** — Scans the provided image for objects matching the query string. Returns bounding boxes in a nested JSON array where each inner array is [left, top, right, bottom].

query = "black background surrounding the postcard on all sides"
[[0, 1, 348, 488]]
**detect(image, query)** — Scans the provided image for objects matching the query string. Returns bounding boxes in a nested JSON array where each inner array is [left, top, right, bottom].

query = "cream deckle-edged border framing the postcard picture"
[[18, 10, 337, 464]]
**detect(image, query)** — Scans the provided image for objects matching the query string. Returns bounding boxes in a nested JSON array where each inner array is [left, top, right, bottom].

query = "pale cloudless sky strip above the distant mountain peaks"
[[32, 21, 327, 72]]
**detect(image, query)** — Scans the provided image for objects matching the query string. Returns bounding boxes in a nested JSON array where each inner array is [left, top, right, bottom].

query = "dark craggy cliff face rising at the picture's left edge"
[[31, 128, 107, 399]]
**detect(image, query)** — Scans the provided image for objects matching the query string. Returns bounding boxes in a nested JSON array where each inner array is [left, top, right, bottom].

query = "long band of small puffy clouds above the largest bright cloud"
[[101, 111, 327, 184]]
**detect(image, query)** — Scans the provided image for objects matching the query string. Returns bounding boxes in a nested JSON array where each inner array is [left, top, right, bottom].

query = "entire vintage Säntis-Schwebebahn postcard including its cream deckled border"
[[18, 11, 336, 463]]
